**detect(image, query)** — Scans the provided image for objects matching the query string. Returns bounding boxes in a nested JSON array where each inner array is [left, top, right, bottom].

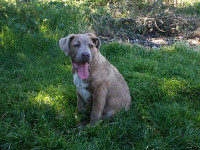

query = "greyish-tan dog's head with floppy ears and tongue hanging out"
[[59, 33, 101, 79]]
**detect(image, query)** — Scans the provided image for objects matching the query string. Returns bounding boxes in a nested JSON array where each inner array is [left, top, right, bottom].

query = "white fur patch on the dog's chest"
[[73, 73, 91, 103]]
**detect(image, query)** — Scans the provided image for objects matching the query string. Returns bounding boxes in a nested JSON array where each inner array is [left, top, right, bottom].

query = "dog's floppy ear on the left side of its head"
[[59, 34, 75, 55]]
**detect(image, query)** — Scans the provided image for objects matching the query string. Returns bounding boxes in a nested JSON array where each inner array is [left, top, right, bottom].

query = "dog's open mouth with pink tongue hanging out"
[[72, 61, 89, 79]]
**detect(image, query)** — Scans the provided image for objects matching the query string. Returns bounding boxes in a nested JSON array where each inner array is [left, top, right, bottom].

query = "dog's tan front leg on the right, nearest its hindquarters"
[[90, 86, 107, 125]]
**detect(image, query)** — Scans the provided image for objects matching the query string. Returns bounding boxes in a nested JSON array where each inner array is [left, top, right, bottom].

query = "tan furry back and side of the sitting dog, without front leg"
[[87, 53, 131, 119]]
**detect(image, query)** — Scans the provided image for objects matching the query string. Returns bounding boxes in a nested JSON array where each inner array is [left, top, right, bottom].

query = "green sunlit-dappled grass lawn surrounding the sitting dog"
[[0, 1, 200, 150]]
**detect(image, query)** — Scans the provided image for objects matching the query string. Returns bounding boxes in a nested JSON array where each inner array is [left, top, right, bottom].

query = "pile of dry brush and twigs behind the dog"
[[89, 2, 197, 39]]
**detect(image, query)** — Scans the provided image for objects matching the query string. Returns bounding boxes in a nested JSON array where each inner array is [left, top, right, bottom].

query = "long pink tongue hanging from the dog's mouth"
[[78, 62, 89, 79]]
